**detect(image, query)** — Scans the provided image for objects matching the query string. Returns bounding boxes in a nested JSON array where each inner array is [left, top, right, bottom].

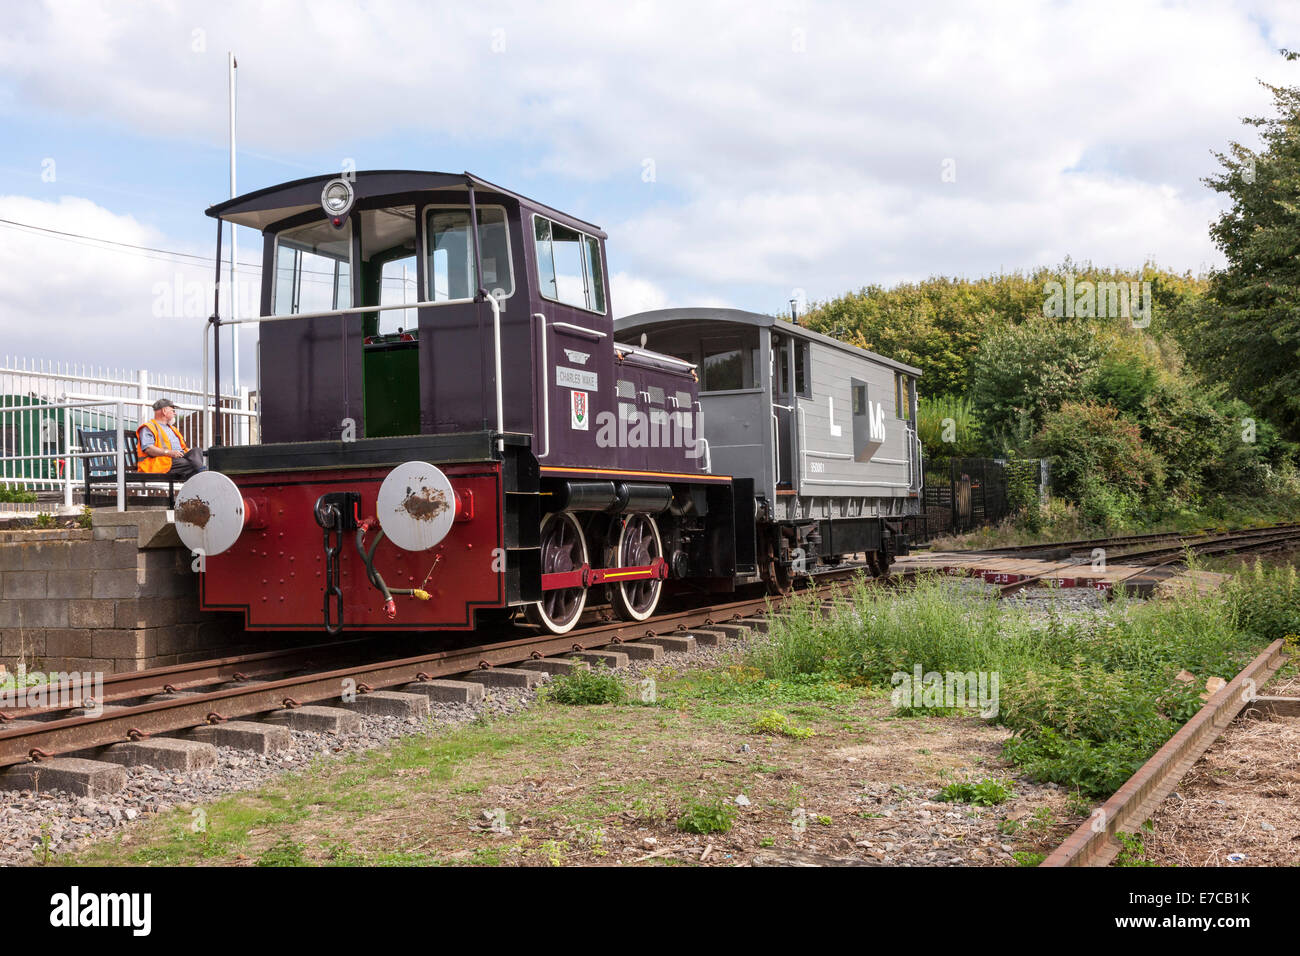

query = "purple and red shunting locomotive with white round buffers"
[[185, 172, 736, 632]]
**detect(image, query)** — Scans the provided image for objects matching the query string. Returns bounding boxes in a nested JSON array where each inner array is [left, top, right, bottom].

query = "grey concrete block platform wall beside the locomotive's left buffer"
[[0, 509, 246, 674]]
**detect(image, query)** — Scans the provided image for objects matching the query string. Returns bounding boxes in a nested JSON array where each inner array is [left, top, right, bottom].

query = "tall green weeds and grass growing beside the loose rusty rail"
[[746, 563, 1300, 799]]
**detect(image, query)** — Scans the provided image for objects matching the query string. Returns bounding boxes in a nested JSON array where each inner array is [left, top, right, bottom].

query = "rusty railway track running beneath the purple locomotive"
[[0, 567, 905, 767]]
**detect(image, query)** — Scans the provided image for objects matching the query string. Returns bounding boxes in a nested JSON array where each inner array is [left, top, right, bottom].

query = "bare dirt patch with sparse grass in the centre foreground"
[[65, 658, 1089, 866]]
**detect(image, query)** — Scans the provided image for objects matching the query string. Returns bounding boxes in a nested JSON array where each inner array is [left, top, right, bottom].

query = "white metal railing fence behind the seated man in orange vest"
[[0, 356, 259, 510]]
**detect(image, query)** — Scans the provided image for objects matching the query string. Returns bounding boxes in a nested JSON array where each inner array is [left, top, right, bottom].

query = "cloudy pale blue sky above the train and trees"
[[0, 0, 1300, 385]]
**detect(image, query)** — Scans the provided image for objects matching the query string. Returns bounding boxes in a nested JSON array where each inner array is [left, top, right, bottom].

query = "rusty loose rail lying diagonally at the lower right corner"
[[1040, 640, 1284, 866]]
